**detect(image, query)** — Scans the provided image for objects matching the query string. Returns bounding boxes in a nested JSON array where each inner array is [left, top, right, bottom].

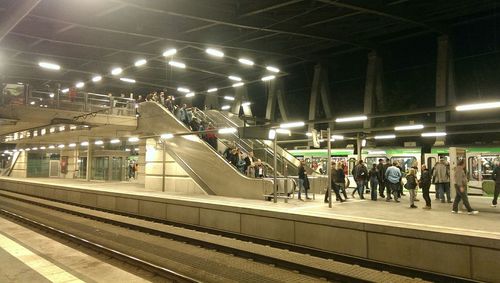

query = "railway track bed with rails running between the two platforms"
[[0, 191, 478, 282]]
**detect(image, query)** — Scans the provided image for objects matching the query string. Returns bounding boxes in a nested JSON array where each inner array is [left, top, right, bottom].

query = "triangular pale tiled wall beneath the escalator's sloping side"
[[143, 139, 205, 194]]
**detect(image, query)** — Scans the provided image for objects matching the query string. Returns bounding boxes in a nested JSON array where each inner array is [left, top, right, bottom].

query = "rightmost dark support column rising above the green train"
[[434, 35, 455, 145]]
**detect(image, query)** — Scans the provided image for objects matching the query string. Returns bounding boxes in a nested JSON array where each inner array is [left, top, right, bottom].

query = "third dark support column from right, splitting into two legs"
[[308, 64, 334, 146]]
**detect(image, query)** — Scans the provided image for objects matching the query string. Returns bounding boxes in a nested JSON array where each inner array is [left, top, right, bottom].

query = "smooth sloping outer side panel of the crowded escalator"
[[138, 102, 273, 199]]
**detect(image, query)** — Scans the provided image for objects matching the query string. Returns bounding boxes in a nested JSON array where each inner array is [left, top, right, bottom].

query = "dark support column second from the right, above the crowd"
[[363, 51, 383, 129]]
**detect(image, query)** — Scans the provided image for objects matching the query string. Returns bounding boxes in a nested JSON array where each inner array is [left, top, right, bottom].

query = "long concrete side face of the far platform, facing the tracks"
[[0, 178, 500, 282]]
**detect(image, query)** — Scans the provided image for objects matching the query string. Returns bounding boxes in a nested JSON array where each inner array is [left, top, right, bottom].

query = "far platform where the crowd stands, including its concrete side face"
[[0, 178, 500, 282]]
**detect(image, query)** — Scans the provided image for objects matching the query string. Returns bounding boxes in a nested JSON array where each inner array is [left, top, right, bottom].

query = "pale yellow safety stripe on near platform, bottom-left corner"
[[0, 234, 84, 283]]
